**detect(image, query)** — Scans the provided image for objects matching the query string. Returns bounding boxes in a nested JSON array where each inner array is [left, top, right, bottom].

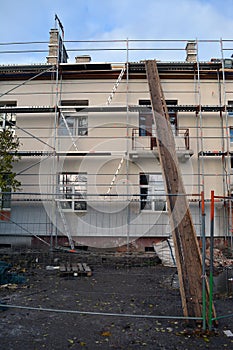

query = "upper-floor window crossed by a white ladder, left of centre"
[[58, 115, 88, 136]]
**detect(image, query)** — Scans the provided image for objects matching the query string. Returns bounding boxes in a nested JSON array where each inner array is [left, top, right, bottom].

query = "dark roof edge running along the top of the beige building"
[[0, 61, 233, 80]]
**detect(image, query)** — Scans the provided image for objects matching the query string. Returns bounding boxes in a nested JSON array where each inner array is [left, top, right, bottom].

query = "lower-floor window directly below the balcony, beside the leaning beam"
[[140, 173, 167, 211]]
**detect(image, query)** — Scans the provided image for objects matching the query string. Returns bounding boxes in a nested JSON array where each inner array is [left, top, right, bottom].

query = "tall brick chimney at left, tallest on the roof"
[[47, 29, 68, 65]]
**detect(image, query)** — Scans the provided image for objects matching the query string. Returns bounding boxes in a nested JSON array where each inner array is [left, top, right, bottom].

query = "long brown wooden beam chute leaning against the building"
[[145, 61, 216, 322]]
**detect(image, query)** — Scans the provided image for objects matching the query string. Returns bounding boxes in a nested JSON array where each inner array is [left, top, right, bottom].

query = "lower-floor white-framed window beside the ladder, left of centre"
[[59, 173, 87, 211]]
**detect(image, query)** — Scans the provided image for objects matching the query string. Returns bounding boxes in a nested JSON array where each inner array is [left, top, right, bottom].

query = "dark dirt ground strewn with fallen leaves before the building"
[[0, 252, 233, 350]]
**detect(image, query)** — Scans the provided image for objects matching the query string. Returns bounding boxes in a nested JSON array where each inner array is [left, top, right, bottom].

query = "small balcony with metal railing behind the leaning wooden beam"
[[129, 128, 193, 163]]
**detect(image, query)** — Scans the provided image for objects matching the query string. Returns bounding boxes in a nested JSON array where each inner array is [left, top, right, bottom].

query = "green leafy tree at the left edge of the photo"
[[0, 129, 21, 209]]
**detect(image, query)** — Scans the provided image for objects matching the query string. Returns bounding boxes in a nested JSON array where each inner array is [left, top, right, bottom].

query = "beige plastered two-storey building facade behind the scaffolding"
[[0, 30, 233, 250]]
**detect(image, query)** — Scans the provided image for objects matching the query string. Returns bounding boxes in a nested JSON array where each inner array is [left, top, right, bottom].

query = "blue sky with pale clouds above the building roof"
[[0, 0, 233, 64]]
